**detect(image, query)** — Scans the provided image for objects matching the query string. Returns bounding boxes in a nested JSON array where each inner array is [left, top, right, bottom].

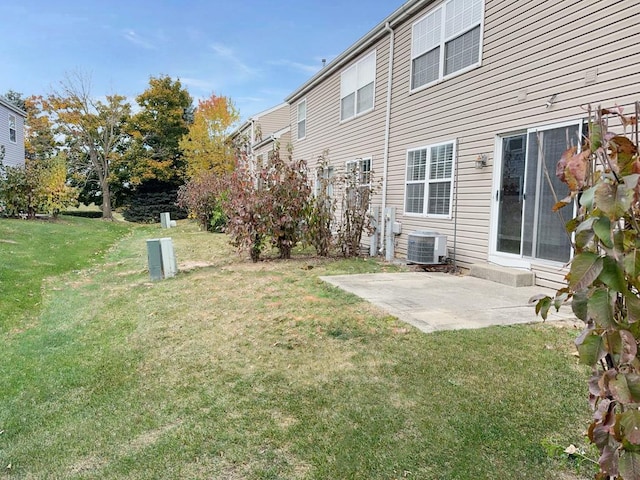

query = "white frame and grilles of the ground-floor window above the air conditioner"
[[403, 140, 458, 219]]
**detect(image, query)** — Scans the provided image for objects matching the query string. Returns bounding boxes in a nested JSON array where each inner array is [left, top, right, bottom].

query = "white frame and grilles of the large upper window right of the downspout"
[[409, 0, 485, 92]]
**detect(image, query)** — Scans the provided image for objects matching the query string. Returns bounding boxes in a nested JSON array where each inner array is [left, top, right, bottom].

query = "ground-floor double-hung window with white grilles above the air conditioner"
[[405, 142, 455, 217]]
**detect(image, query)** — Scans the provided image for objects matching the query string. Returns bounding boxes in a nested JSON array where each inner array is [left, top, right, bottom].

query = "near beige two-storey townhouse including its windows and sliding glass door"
[[282, 0, 640, 286]]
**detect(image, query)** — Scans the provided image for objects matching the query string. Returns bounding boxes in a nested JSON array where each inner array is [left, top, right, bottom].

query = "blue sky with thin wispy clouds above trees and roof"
[[0, 0, 404, 118]]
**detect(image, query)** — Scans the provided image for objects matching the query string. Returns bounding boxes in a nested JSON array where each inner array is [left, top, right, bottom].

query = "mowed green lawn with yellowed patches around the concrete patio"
[[0, 219, 593, 480]]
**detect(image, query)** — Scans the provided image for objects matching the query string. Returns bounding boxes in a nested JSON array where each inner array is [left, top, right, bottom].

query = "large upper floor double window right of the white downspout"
[[411, 0, 483, 90]]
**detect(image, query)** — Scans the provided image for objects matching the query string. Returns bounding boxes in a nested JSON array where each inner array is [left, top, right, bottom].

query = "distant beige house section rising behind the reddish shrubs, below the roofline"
[[231, 103, 291, 169]]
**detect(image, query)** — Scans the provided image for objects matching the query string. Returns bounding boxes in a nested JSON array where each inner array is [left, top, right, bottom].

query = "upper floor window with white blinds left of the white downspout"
[[340, 51, 376, 120]]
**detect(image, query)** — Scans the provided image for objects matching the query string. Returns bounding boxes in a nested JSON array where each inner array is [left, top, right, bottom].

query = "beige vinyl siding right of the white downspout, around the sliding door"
[[376, 0, 640, 286]]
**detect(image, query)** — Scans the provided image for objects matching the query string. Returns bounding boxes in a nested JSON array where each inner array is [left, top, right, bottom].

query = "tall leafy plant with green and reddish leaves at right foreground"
[[532, 104, 640, 480]]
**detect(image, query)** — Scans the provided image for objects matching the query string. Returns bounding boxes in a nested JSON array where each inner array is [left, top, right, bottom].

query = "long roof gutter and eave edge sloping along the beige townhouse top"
[[285, 0, 428, 103]]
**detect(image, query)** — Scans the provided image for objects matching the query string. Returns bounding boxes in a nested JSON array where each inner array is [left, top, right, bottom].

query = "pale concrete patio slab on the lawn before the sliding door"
[[320, 272, 576, 332]]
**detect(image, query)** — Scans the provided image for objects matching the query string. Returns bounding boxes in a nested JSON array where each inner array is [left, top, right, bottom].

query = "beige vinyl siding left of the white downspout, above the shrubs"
[[290, 37, 389, 213]]
